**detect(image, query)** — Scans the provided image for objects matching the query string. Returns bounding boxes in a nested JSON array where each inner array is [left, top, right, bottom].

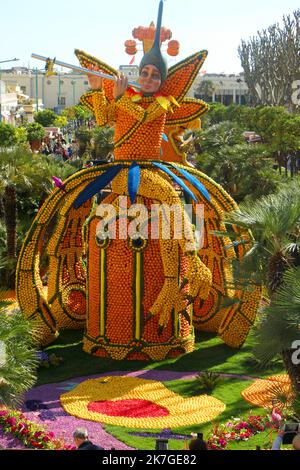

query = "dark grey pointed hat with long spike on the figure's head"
[[139, 0, 168, 82]]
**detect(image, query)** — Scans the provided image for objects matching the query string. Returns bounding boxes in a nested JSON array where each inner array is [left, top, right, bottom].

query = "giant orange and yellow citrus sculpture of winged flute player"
[[16, 2, 260, 360]]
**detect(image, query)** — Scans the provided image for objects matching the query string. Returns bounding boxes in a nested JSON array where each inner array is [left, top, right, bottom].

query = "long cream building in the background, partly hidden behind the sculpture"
[[0, 65, 248, 121]]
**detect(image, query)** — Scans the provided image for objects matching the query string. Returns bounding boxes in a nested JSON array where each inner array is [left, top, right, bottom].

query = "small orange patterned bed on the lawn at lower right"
[[241, 374, 293, 408]]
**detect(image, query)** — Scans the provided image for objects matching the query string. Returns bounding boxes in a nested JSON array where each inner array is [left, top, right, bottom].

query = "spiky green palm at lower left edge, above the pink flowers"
[[0, 301, 37, 407]]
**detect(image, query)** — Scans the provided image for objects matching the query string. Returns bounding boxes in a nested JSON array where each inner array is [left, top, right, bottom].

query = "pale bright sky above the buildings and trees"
[[0, 0, 299, 73]]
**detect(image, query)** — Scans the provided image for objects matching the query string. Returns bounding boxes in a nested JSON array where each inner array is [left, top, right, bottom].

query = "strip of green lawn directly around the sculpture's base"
[[37, 331, 284, 385]]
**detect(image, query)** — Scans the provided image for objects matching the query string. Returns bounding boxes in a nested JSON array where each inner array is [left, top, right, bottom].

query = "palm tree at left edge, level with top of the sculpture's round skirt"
[[0, 147, 76, 287]]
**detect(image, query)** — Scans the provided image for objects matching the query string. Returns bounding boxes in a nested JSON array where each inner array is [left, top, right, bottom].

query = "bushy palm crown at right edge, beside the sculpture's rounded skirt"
[[220, 181, 300, 294]]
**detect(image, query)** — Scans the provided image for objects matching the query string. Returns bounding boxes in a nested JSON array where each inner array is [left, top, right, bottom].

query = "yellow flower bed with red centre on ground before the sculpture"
[[60, 376, 225, 429]]
